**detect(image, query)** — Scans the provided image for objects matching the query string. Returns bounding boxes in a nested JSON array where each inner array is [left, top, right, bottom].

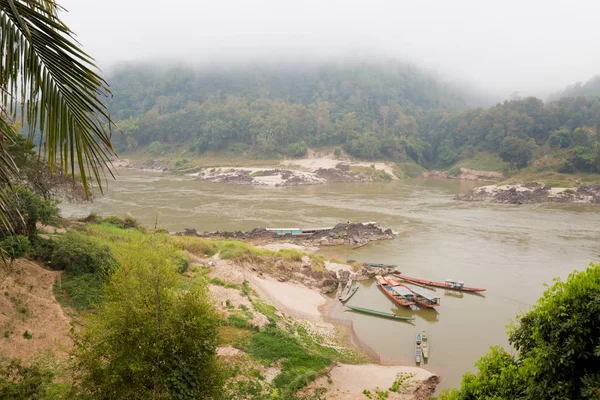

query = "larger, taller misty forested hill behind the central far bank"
[[109, 62, 474, 157]]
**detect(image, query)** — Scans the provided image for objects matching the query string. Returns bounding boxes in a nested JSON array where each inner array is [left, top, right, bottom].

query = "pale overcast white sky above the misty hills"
[[59, 0, 600, 97]]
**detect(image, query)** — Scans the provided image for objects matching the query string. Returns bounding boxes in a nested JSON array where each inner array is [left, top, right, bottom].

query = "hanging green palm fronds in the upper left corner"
[[0, 0, 114, 227]]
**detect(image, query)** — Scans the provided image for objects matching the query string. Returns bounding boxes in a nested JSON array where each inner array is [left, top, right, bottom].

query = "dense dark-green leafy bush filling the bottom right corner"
[[440, 264, 600, 400]]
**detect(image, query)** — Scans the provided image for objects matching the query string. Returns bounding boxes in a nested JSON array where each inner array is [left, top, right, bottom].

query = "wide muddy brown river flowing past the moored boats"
[[61, 169, 600, 388]]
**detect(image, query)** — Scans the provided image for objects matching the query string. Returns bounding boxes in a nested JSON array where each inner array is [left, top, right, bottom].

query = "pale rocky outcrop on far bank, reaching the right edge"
[[454, 182, 600, 204]]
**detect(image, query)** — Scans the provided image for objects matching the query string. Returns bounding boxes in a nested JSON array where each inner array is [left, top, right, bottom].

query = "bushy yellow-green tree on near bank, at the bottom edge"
[[75, 238, 222, 399]]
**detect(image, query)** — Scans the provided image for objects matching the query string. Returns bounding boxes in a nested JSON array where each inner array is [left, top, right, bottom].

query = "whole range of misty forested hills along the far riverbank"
[[109, 62, 600, 172]]
